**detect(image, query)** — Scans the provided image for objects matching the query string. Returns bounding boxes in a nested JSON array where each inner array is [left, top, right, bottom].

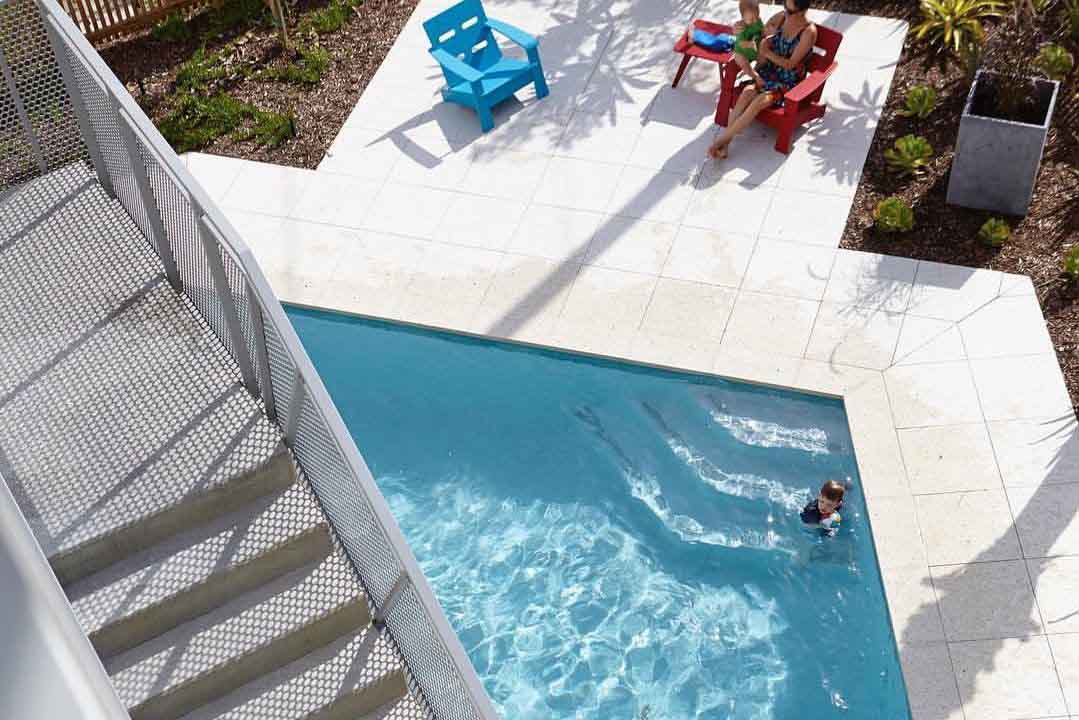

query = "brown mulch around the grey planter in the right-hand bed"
[[814, 0, 1079, 406]]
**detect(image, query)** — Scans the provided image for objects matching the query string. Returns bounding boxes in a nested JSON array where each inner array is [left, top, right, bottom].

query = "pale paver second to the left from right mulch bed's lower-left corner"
[[663, 226, 756, 287]]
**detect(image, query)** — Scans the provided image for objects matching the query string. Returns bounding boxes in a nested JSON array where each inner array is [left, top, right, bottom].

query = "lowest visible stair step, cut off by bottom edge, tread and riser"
[[183, 626, 410, 720]]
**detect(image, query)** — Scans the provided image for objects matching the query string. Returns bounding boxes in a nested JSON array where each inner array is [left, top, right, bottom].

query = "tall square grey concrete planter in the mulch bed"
[[947, 70, 1060, 215]]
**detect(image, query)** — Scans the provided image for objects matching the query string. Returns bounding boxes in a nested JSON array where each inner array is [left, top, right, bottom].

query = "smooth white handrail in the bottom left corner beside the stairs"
[[0, 475, 131, 720]]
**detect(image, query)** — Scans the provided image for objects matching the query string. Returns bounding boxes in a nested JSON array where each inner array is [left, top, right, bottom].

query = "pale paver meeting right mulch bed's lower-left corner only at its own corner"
[[742, 237, 835, 300]]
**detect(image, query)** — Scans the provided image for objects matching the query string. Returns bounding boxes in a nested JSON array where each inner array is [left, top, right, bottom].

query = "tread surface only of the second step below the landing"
[[106, 551, 366, 708]]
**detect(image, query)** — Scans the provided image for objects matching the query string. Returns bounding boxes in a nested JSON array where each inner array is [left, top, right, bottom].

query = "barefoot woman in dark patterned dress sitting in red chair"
[[708, 0, 817, 160]]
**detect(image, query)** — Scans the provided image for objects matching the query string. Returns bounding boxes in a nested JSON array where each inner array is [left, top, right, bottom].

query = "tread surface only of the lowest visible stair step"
[[182, 627, 407, 720]]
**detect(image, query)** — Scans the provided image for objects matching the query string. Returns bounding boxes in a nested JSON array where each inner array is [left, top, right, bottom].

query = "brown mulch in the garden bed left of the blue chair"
[[100, 0, 419, 168]]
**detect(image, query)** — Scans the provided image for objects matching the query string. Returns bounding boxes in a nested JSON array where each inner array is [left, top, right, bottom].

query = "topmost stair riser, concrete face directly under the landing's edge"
[[49, 445, 296, 586]]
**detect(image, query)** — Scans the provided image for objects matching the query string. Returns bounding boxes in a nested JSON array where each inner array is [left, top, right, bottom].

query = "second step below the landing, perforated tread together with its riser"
[[105, 549, 370, 720]]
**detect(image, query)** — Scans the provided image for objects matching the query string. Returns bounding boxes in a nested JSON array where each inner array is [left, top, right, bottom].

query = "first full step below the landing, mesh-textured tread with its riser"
[[66, 483, 331, 657]]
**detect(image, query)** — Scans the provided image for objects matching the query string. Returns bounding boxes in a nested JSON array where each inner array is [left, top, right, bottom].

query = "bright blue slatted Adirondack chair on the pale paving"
[[423, 0, 548, 133]]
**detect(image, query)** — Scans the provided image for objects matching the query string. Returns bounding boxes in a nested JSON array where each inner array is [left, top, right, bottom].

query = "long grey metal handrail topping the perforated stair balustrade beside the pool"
[[35, 0, 498, 720]]
